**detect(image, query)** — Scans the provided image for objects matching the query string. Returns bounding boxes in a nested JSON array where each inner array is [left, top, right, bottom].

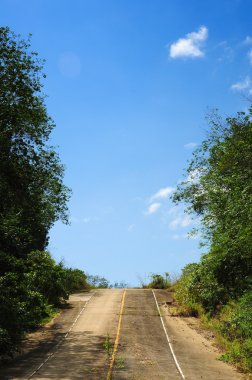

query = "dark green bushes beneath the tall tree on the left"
[[0, 251, 88, 356]]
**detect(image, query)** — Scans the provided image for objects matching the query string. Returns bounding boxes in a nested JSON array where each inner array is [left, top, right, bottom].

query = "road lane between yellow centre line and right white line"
[[113, 289, 181, 380]]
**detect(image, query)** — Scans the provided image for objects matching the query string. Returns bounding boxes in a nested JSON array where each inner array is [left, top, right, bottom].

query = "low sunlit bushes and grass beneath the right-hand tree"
[[175, 264, 252, 371]]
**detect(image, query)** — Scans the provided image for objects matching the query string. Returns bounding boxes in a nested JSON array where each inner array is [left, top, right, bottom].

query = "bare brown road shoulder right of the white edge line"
[[155, 290, 246, 380]]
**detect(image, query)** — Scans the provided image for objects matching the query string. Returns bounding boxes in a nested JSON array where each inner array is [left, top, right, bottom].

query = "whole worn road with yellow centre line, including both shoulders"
[[0, 289, 242, 380]]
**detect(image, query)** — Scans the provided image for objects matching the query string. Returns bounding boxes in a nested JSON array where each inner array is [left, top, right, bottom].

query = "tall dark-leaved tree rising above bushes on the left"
[[0, 27, 69, 257]]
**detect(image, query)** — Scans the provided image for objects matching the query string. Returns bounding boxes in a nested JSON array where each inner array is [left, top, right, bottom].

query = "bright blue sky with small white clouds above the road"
[[0, 0, 252, 285]]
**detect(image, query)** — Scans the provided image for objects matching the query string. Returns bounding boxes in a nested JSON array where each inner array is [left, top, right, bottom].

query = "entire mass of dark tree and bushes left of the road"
[[0, 27, 89, 358]]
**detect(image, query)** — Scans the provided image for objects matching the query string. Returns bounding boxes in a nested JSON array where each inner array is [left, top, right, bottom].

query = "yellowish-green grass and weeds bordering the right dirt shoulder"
[[169, 282, 252, 379]]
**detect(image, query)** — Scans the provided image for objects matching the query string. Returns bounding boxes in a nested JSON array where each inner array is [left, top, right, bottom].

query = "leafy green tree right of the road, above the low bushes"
[[173, 107, 252, 307]]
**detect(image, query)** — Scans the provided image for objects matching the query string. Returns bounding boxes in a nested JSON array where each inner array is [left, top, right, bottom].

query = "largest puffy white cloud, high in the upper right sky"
[[170, 26, 208, 58]]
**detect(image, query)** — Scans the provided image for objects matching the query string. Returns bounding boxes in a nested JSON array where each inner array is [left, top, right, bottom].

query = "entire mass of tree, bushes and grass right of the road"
[[173, 107, 252, 372]]
